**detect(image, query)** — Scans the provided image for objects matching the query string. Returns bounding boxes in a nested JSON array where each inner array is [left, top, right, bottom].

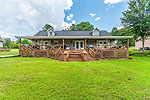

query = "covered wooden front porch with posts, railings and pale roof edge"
[[17, 36, 131, 61]]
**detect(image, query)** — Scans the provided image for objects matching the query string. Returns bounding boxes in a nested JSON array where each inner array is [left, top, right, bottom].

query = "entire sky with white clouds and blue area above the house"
[[0, 0, 128, 40]]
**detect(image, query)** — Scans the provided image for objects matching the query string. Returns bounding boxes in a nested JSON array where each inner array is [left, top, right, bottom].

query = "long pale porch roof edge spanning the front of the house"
[[16, 36, 133, 40]]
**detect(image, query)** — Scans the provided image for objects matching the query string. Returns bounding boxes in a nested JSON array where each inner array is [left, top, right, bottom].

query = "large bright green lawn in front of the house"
[[0, 56, 150, 100]]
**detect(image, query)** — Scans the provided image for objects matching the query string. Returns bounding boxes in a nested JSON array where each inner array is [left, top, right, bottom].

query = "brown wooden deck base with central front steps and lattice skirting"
[[19, 47, 129, 61]]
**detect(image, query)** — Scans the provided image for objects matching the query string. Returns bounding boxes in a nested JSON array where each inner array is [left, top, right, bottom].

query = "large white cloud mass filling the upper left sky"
[[0, 0, 73, 39]]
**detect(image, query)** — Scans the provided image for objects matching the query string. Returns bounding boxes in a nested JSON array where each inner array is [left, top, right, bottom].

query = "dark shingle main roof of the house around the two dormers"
[[34, 30, 112, 36]]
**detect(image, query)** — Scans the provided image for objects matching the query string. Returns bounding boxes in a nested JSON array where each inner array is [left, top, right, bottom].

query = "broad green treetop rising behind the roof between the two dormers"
[[67, 22, 94, 31]]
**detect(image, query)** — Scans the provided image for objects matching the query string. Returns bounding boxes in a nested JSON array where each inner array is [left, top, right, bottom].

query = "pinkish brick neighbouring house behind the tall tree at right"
[[135, 37, 150, 50]]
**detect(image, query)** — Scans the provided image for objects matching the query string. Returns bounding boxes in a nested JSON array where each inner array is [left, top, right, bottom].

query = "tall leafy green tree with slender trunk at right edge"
[[121, 0, 150, 55]]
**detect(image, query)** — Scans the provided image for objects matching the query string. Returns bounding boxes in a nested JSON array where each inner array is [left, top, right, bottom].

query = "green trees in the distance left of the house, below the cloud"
[[4, 38, 31, 49]]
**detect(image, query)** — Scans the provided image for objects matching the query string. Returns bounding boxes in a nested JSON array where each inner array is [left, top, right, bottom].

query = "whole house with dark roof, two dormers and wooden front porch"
[[16, 28, 132, 61]]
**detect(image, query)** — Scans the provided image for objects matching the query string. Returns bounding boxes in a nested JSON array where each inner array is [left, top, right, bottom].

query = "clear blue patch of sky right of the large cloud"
[[65, 0, 127, 31]]
